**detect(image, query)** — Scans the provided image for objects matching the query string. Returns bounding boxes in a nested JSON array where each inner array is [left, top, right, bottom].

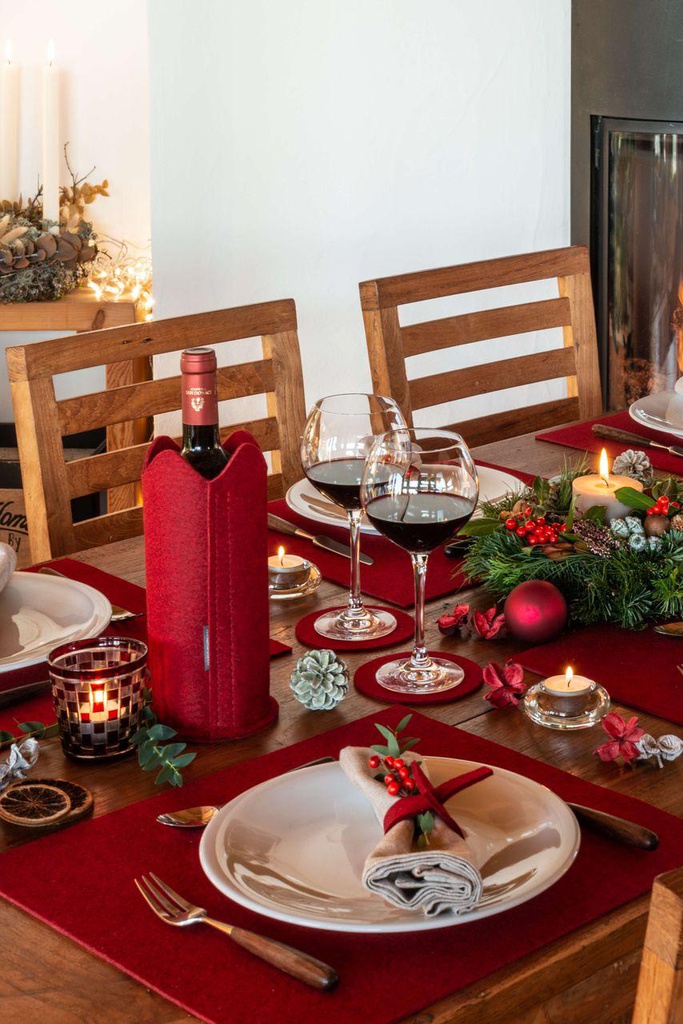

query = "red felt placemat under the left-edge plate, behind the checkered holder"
[[0, 558, 292, 733]]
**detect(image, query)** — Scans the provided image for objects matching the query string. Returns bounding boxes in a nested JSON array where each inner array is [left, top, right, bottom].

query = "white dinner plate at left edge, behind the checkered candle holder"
[[0, 572, 112, 674]]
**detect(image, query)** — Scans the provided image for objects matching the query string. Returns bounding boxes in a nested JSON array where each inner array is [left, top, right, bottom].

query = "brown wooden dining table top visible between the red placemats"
[[0, 434, 683, 1024]]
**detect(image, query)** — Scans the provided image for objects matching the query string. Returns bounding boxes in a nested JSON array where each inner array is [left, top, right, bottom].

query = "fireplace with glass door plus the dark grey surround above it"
[[571, 0, 683, 409]]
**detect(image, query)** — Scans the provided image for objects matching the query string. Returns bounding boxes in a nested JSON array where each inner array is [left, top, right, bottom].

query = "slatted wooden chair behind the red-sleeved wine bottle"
[[7, 299, 305, 561]]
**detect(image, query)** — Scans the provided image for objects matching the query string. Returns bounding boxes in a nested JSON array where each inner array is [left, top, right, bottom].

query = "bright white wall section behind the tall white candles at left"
[[0, 0, 151, 422]]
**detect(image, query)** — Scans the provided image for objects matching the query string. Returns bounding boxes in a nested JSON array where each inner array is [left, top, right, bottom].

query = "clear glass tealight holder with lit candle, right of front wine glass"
[[522, 668, 610, 729]]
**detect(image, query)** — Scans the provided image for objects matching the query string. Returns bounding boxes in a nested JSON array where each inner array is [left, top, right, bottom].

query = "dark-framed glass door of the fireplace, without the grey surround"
[[591, 116, 683, 409]]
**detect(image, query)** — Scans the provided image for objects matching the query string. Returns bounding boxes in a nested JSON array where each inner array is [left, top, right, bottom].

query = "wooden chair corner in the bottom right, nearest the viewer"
[[633, 867, 683, 1024]]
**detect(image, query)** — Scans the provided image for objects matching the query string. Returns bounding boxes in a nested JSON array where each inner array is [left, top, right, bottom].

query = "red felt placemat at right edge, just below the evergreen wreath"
[[515, 626, 683, 725]]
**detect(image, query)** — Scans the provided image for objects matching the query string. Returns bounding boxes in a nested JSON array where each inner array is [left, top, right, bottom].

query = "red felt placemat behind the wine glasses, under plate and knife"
[[268, 462, 533, 608]]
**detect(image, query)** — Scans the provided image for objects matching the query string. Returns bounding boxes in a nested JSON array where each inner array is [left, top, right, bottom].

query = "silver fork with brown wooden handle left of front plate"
[[133, 871, 339, 991]]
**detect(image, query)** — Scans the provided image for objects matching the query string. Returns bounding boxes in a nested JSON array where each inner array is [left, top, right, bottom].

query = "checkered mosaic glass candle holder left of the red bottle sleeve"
[[47, 637, 147, 761]]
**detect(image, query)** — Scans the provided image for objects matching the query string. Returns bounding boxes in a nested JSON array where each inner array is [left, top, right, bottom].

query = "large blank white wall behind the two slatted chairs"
[[148, 0, 570, 430]]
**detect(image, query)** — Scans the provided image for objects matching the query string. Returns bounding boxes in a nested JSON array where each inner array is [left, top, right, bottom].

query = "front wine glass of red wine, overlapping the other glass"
[[360, 428, 479, 693]]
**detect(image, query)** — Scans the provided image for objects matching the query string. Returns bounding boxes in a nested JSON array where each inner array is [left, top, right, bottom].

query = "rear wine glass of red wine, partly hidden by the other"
[[301, 394, 405, 640]]
